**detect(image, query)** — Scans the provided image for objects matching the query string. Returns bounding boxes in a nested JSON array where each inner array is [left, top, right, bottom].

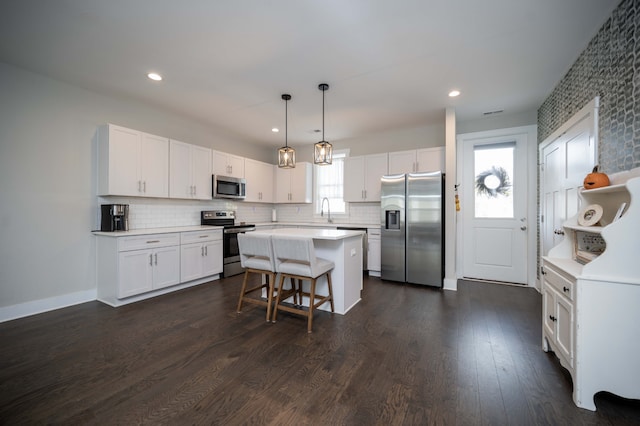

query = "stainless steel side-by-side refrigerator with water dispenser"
[[381, 172, 444, 287]]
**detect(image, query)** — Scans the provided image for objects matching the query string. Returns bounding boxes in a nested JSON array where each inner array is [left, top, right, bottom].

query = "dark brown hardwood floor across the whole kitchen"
[[0, 276, 640, 425]]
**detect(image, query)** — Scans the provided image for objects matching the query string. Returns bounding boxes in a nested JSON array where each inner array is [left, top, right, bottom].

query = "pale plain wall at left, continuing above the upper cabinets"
[[0, 63, 273, 314]]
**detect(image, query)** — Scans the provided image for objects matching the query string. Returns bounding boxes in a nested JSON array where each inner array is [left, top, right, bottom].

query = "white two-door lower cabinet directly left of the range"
[[180, 231, 222, 282]]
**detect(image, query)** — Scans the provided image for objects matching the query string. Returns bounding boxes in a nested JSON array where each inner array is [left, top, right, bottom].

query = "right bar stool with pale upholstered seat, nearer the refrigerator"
[[271, 235, 335, 333]]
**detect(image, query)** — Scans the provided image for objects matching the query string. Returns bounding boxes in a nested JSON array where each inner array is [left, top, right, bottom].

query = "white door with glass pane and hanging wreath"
[[461, 133, 535, 284]]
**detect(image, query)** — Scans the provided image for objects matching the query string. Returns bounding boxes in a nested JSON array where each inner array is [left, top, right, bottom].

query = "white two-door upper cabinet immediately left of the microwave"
[[169, 140, 211, 200]]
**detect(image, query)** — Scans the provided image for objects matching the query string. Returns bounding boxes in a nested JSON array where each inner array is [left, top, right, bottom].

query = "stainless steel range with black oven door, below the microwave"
[[200, 210, 256, 277]]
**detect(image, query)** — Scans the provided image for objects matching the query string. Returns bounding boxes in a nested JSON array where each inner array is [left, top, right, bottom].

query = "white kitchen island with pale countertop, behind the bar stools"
[[255, 228, 364, 315]]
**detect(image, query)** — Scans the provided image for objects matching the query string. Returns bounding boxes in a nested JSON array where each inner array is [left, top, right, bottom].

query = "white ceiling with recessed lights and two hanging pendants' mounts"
[[0, 0, 619, 146]]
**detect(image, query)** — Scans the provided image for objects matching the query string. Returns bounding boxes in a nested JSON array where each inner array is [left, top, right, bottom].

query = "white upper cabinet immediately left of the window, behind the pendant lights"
[[275, 163, 313, 203]]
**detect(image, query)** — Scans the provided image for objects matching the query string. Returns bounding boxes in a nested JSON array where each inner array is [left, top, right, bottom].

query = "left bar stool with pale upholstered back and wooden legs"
[[238, 233, 276, 322]]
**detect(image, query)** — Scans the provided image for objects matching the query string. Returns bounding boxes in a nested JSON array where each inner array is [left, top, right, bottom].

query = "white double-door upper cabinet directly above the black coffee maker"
[[98, 124, 169, 197]]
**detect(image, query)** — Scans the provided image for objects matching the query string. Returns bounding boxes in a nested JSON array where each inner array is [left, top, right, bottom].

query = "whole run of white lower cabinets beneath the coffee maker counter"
[[96, 229, 222, 306]]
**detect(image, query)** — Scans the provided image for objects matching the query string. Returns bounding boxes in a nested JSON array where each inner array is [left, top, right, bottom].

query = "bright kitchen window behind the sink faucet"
[[313, 150, 349, 216]]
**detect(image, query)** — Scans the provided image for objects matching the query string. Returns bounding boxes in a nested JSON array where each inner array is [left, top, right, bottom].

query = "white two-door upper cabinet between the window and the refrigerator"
[[344, 153, 388, 202]]
